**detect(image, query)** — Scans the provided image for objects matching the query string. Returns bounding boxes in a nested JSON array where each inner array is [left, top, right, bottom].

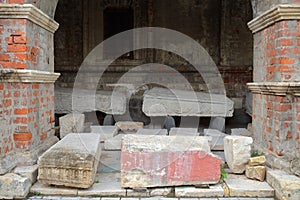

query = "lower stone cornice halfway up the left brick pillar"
[[0, 69, 60, 83]]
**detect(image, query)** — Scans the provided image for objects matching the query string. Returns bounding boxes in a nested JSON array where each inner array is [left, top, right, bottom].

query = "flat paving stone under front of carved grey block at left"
[[30, 181, 77, 196]]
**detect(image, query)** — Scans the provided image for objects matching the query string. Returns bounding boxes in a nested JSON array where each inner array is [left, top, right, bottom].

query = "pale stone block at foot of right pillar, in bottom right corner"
[[267, 169, 300, 200]]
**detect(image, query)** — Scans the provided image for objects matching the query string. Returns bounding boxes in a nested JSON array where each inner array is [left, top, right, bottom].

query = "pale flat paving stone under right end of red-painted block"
[[175, 184, 224, 198]]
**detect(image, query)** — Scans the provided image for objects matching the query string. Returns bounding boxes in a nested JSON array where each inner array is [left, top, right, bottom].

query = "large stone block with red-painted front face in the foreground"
[[121, 135, 222, 188]]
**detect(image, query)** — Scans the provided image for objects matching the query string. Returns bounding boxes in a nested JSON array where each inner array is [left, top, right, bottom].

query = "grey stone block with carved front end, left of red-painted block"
[[38, 133, 101, 188]]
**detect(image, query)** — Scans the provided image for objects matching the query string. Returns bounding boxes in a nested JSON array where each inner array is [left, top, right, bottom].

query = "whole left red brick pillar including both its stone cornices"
[[0, 3, 59, 174]]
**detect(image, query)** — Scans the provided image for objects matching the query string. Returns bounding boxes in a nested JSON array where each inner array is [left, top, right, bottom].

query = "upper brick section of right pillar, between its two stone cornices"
[[254, 20, 300, 82]]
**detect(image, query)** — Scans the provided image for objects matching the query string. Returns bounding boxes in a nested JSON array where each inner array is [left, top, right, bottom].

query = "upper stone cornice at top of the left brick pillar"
[[0, 3, 59, 33]]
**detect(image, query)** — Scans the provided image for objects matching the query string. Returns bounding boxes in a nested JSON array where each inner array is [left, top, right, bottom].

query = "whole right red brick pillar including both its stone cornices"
[[248, 5, 300, 174]]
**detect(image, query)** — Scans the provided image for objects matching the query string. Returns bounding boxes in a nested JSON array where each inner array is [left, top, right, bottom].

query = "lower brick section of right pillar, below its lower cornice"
[[253, 94, 300, 170]]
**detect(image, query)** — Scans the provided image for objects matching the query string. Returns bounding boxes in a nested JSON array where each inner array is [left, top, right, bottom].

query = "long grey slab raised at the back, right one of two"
[[142, 88, 234, 117]]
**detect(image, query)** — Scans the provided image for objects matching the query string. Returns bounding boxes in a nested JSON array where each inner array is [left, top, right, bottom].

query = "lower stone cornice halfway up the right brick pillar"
[[247, 82, 300, 96]]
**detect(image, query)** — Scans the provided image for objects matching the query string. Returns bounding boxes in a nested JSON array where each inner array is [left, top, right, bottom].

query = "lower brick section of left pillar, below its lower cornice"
[[0, 83, 54, 156]]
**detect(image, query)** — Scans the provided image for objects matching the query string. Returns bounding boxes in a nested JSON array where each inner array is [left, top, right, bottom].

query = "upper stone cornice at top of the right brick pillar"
[[248, 4, 300, 33]]
